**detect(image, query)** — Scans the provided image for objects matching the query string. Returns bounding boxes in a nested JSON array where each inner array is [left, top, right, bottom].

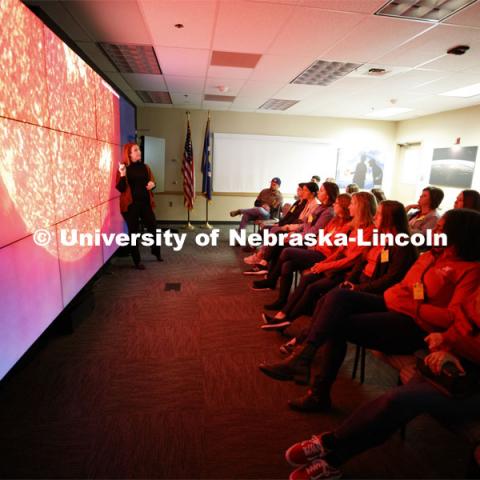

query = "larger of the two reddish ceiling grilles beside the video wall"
[[98, 43, 162, 75]]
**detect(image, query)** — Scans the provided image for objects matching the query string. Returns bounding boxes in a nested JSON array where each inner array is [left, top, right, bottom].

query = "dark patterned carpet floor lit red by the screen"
[[0, 228, 468, 479]]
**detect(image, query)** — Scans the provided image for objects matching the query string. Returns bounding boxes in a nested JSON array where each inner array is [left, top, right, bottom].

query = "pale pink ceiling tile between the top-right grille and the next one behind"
[[322, 16, 431, 63]]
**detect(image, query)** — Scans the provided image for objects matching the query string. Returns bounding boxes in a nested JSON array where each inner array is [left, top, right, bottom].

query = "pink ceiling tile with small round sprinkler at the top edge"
[[138, 0, 216, 49]]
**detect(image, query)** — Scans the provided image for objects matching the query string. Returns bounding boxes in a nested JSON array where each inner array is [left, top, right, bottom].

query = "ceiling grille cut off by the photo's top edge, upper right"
[[375, 0, 477, 22]]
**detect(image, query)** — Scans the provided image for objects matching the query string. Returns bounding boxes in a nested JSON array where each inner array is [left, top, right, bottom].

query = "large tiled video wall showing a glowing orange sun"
[[0, 0, 129, 379]]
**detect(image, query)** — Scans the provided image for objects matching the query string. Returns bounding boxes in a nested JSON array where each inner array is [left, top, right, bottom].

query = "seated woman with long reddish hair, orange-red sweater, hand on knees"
[[252, 192, 377, 310]]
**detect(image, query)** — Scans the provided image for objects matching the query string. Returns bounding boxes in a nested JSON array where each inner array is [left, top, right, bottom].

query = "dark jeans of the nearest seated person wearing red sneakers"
[[333, 379, 480, 463]]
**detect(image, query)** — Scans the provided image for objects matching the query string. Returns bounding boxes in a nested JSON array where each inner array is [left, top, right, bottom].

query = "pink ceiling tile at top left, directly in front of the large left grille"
[[62, 0, 151, 45]]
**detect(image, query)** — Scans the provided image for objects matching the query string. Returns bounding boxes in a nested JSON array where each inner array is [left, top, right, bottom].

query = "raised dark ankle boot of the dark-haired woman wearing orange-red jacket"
[[259, 343, 317, 385]]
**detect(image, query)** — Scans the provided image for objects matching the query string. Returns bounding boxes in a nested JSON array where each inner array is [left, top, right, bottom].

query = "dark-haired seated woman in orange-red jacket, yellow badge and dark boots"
[[260, 209, 480, 411]]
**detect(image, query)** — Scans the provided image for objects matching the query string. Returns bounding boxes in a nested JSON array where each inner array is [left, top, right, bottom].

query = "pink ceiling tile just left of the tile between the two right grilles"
[[268, 8, 365, 57]]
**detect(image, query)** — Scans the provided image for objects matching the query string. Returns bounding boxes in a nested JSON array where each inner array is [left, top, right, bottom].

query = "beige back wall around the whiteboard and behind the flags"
[[137, 107, 397, 221]]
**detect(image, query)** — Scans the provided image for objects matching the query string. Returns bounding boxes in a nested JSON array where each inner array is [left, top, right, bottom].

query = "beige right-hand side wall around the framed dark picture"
[[392, 106, 480, 210]]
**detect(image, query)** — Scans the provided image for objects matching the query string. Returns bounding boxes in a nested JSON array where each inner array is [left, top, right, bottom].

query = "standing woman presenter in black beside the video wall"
[[116, 143, 162, 270]]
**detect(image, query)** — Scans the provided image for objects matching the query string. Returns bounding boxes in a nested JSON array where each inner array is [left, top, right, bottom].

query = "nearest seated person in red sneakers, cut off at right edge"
[[285, 288, 480, 480]]
